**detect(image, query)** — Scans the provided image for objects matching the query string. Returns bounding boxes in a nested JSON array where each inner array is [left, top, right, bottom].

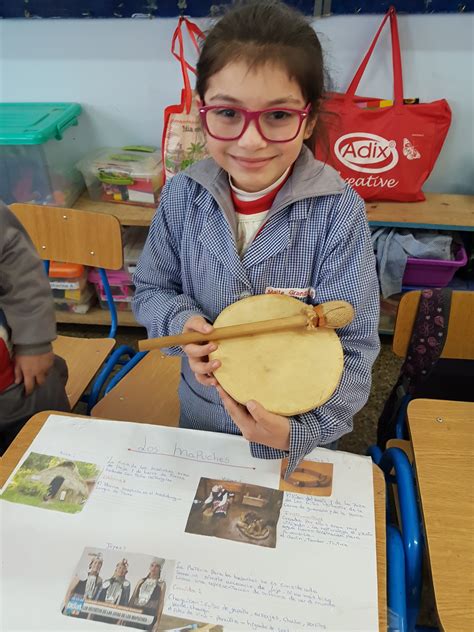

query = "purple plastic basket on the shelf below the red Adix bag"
[[402, 244, 467, 287]]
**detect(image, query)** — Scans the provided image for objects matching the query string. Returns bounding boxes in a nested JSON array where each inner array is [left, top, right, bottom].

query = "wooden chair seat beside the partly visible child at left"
[[53, 336, 115, 408]]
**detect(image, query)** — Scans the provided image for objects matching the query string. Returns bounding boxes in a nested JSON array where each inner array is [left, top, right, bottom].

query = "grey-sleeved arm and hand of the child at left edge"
[[0, 203, 56, 395]]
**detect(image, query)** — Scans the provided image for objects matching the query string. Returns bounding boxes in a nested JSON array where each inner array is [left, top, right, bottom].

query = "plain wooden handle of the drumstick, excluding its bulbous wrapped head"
[[138, 312, 308, 351]]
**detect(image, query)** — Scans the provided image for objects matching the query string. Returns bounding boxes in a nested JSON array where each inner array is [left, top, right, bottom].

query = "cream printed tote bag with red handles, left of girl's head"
[[161, 17, 207, 180]]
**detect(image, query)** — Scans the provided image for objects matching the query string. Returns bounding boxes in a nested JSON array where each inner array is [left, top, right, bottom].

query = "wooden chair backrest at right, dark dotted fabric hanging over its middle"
[[393, 290, 474, 360]]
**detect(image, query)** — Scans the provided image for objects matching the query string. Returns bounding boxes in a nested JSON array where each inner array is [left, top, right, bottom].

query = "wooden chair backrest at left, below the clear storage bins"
[[10, 204, 123, 270]]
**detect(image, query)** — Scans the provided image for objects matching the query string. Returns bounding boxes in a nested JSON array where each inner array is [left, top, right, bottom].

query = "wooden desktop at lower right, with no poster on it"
[[408, 399, 474, 632]]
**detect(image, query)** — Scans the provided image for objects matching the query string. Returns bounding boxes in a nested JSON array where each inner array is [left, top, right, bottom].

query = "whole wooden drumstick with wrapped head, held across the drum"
[[138, 301, 354, 351]]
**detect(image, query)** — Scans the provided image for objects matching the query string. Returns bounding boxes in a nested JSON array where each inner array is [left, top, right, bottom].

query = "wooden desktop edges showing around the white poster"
[[0, 411, 387, 632]]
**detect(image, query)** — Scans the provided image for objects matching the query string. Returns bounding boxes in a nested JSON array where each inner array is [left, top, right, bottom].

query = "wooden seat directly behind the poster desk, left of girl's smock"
[[91, 351, 181, 426]]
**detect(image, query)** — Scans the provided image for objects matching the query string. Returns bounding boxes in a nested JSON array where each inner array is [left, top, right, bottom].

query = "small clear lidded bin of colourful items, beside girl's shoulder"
[[77, 146, 163, 207]]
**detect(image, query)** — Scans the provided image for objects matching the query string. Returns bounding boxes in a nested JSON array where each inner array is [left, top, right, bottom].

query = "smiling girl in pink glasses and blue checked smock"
[[134, 1, 379, 472]]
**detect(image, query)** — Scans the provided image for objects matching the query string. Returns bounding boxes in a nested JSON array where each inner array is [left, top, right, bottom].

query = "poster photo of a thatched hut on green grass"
[[0, 452, 100, 513]]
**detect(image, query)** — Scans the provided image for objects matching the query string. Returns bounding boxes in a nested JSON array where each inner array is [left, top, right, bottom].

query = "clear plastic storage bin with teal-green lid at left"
[[0, 103, 84, 206]]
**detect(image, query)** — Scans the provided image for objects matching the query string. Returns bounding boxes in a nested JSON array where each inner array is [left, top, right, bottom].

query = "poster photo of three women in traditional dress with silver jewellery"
[[61, 547, 175, 632]]
